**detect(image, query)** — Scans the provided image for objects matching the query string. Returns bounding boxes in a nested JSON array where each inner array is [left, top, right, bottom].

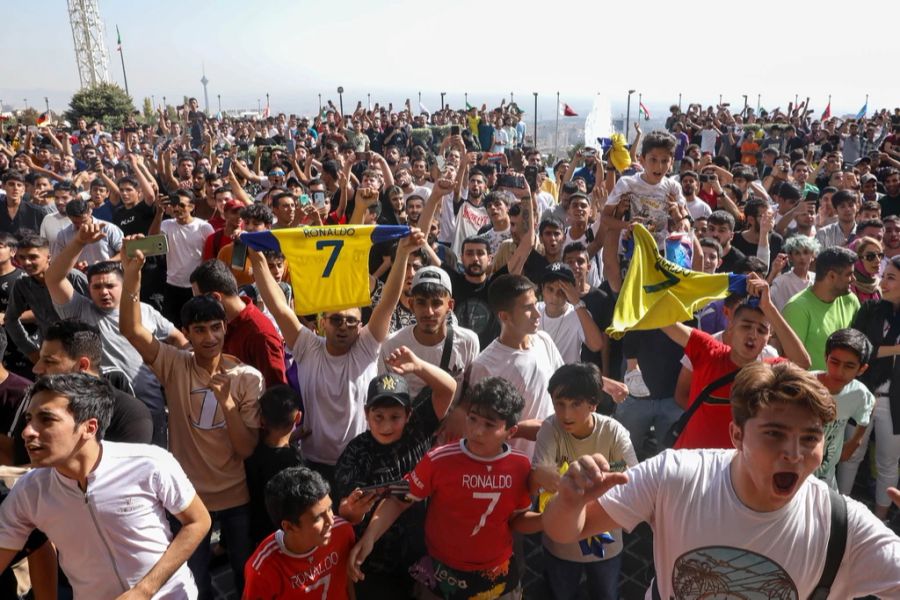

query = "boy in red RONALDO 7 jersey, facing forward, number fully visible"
[[349, 377, 540, 600]]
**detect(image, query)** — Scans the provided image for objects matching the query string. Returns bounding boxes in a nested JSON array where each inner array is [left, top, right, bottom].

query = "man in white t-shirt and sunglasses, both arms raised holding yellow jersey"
[[248, 229, 425, 480]]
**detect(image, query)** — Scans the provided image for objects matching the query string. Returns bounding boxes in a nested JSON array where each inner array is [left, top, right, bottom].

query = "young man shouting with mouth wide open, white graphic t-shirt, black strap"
[[543, 362, 900, 598]]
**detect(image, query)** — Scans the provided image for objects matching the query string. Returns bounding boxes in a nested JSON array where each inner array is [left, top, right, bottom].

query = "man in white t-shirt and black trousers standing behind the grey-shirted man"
[[156, 190, 214, 327]]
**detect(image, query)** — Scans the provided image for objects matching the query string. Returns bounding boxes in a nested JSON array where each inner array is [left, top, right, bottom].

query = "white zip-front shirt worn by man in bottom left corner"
[[0, 442, 197, 598]]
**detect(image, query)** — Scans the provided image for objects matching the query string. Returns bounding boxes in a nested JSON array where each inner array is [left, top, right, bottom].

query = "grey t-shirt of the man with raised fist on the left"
[[54, 294, 175, 412]]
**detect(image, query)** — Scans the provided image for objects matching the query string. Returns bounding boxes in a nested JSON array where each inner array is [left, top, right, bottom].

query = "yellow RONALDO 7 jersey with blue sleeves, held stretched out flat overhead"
[[241, 225, 410, 315]]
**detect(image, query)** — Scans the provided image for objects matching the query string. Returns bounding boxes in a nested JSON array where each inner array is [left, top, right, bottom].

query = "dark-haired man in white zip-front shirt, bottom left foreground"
[[0, 373, 210, 598]]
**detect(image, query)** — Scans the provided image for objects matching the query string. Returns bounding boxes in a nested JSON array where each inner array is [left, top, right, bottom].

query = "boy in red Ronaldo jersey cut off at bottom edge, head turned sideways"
[[243, 467, 356, 600]]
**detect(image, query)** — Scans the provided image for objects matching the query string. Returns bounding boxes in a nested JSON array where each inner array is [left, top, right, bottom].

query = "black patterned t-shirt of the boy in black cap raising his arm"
[[332, 388, 440, 574]]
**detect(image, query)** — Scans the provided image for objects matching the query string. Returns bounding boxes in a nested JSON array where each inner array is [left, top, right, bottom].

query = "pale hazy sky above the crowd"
[[0, 0, 900, 120]]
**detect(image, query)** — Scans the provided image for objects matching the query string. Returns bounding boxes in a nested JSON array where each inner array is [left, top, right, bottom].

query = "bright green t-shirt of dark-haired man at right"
[[783, 287, 859, 371]]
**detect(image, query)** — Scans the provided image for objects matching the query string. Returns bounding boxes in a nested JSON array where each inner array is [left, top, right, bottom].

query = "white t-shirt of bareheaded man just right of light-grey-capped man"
[[469, 331, 565, 456]]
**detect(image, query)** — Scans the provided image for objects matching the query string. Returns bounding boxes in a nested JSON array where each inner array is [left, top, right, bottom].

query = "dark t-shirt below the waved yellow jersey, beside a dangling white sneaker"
[[622, 329, 684, 400]]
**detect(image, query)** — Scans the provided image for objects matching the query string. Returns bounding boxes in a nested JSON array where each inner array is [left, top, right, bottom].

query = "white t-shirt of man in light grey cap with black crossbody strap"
[[380, 324, 481, 399]]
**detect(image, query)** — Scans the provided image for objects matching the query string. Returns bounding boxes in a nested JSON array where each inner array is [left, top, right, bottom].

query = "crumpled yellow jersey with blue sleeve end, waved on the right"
[[606, 224, 747, 339]]
